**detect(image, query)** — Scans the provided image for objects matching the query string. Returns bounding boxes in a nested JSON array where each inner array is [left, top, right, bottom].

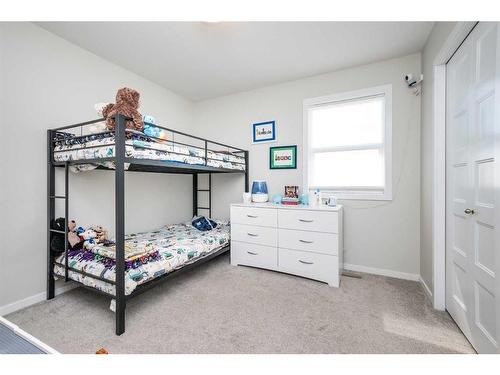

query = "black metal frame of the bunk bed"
[[47, 114, 249, 335]]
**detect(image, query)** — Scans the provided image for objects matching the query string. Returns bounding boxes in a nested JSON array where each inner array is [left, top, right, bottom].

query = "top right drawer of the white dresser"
[[278, 209, 339, 233]]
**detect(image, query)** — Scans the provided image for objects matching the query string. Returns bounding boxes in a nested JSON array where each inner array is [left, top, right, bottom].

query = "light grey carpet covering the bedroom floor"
[[7, 256, 474, 353]]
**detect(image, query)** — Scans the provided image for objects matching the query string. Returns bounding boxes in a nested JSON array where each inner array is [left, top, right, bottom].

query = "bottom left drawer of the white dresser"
[[231, 241, 278, 270]]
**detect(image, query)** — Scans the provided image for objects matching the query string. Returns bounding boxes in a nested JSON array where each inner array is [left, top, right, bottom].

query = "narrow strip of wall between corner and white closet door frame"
[[420, 22, 456, 291]]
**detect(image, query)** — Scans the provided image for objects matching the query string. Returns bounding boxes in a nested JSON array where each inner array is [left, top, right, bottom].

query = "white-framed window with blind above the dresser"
[[304, 85, 392, 200]]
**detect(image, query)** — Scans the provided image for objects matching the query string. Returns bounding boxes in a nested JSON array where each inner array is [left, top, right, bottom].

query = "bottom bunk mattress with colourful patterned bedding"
[[54, 221, 230, 295]]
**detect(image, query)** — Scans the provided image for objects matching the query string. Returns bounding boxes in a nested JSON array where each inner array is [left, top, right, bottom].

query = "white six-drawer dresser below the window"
[[231, 203, 343, 287]]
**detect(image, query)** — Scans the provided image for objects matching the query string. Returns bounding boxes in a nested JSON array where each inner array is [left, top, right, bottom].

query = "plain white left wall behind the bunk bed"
[[0, 23, 192, 307]]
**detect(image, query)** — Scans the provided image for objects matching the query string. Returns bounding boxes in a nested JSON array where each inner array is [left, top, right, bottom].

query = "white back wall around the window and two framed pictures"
[[194, 54, 421, 276]]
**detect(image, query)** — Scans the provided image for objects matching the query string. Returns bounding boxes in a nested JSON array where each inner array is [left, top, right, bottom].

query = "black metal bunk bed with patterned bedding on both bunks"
[[47, 115, 249, 335]]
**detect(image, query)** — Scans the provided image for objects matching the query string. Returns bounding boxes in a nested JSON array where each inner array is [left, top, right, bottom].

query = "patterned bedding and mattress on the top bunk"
[[54, 131, 245, 171]]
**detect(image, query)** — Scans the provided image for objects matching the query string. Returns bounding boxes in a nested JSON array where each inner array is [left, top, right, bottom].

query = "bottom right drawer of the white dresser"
[[278, 248, 339, 287]]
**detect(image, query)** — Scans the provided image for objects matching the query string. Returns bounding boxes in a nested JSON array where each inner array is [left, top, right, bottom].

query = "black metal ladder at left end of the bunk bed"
[[47, 130, 69, 299]]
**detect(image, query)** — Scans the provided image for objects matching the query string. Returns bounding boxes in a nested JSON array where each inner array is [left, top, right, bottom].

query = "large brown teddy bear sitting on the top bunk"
[[102, 87, 144, 132]]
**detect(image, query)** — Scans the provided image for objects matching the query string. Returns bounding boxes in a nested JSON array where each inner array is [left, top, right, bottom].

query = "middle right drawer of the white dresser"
[[278, 229, 339, 255]]
